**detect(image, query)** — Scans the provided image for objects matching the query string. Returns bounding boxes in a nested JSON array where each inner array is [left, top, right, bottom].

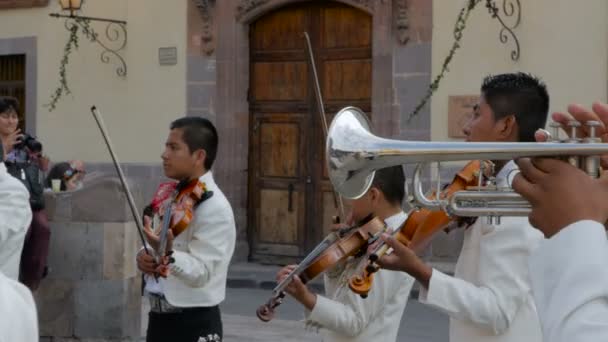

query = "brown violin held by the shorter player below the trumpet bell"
[[256, 217, 387, 322]]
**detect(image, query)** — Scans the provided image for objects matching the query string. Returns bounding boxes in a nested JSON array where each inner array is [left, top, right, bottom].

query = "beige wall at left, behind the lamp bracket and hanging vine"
[[0, 0, 187, 162]]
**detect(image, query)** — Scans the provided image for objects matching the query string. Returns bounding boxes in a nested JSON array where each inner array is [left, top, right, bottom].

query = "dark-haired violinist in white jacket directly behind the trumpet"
[[379, 73, 549, 342]]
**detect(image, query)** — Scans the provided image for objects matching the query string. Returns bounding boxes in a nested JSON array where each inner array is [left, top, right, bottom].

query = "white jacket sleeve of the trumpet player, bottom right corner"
[[530, 221, 608, 342]]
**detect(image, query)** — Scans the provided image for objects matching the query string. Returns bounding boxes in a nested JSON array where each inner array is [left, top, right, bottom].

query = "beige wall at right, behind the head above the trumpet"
[[431, 0, 608, 140]]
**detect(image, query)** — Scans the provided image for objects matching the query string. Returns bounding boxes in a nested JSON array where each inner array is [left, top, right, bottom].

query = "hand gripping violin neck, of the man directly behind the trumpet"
[[378, 234, 433, 289]]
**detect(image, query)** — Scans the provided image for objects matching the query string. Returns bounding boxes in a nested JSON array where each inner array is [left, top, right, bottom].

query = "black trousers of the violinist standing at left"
[[146, 305, 223, 342]]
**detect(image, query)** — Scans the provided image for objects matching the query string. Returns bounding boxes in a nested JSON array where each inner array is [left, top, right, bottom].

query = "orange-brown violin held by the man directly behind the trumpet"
[[348, 160, 490, 298]]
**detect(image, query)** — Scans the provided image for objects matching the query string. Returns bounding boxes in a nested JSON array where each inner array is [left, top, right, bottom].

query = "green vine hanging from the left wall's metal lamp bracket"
[[44, 18, 97, 112]]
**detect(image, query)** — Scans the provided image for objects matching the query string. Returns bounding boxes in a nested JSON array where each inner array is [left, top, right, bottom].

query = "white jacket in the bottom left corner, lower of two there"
[[0, 270, 39, 342]]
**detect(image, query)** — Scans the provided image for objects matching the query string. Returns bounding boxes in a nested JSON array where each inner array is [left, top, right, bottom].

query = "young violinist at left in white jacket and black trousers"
[[137, 117, 236, 342]]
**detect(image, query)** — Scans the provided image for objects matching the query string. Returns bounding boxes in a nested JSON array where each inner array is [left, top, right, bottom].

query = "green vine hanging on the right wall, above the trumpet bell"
[[407, 0, 491, 123]]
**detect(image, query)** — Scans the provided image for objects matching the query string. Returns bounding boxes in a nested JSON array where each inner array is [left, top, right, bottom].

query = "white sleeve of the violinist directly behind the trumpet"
[[419, 217, 542, 335]]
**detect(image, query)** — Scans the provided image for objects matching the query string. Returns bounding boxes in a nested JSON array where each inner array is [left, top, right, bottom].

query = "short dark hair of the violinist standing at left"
[[171, 117, 218, 170]]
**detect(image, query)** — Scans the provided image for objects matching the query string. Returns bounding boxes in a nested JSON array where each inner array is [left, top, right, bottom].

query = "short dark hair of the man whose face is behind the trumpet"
[[481, 72, 549, 142]]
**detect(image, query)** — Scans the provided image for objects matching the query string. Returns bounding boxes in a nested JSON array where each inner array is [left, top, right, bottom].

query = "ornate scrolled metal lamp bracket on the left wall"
[[49, 13, 127, 77]]
